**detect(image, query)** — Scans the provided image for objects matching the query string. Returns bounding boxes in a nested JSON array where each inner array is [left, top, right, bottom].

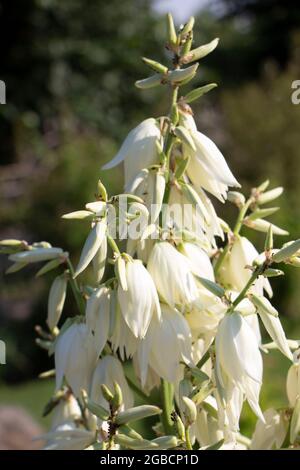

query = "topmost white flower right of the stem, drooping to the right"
[[179, 116, 240, 201]]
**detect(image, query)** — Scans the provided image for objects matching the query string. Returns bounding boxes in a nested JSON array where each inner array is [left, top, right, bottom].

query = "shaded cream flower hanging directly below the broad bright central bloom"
[[137, 304, 193, 386]]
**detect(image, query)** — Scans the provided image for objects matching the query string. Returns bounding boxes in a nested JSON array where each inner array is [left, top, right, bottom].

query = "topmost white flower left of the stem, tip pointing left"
[[103, 118, 161, 187]]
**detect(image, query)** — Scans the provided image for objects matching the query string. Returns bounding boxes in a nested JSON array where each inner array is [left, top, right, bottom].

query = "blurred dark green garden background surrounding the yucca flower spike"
[[0, 0, 300, 444]]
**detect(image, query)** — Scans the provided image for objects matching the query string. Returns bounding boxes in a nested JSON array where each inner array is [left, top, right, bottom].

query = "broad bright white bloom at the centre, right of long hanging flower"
[[147, 242, 198, 307]]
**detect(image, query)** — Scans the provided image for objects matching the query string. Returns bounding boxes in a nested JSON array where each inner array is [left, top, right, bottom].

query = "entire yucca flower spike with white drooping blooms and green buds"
[[1, 15, 300, 450]]
